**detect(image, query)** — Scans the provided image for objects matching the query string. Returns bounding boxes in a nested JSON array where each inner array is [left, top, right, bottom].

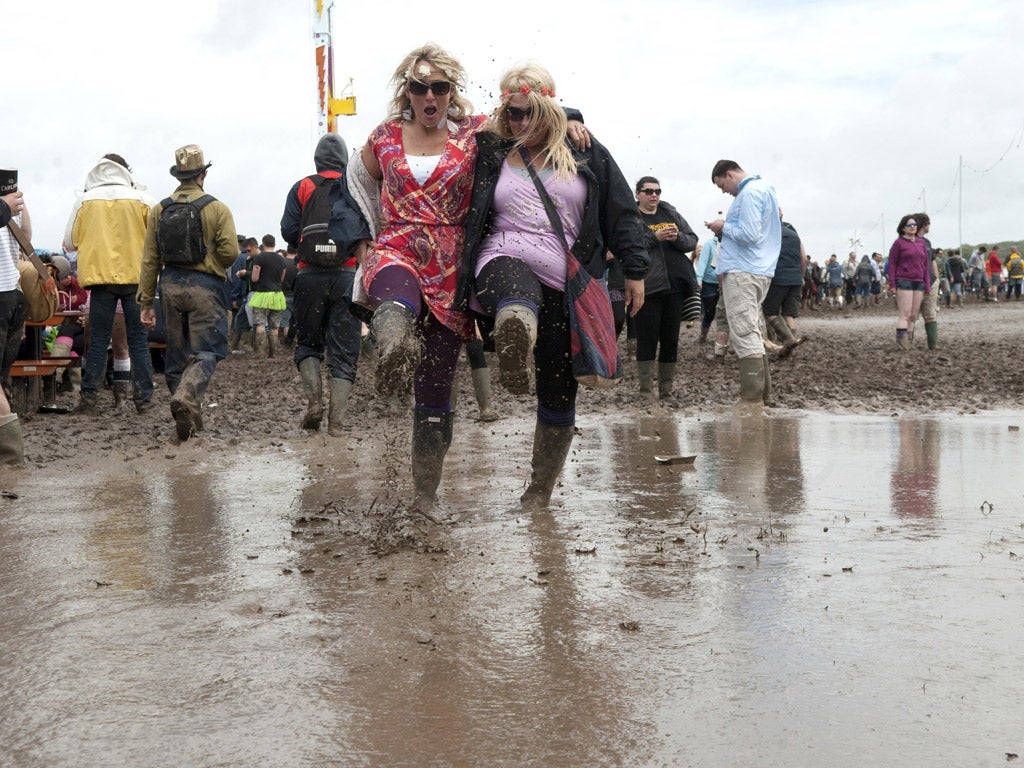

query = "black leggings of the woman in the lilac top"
[[476, 256, 579, 426]]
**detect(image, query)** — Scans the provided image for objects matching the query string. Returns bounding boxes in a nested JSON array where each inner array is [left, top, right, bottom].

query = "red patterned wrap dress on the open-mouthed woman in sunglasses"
[[362, 116, 485, 339]]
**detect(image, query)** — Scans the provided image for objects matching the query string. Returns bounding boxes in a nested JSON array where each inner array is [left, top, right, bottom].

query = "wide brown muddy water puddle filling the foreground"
[[0, 413, 1024, 766]]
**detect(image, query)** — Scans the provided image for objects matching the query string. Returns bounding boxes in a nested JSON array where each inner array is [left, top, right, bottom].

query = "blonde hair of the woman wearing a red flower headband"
[[490, 63, 577, 177]]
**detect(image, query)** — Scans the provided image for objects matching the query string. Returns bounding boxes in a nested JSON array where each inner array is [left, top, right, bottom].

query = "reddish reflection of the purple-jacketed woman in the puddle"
[[889, 419, 939, 518]]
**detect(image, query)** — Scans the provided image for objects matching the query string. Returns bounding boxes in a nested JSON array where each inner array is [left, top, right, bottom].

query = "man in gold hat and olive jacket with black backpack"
[[138, 144, 239, 440]]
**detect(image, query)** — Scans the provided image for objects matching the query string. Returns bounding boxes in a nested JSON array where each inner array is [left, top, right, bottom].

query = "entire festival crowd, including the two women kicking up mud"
[[0, 44, 1011, 516]]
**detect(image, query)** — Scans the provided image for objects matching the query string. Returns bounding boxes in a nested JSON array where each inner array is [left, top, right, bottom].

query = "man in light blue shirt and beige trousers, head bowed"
[[705, 160, 782, 403]]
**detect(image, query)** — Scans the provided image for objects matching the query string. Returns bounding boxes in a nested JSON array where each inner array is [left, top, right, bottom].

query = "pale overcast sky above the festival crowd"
[[8, 0, 1024, 258]]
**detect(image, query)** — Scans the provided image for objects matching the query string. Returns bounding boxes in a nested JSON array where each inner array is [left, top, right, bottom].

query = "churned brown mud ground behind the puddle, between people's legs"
[[9, 302, 1024, 469]]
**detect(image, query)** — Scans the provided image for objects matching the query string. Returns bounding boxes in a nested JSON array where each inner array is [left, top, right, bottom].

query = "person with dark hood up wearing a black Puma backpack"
[[281, 133, 371, 437]]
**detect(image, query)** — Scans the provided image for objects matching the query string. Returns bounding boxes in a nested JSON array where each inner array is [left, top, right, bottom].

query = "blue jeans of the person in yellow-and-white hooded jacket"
[[82, 285, 154, 403]]
